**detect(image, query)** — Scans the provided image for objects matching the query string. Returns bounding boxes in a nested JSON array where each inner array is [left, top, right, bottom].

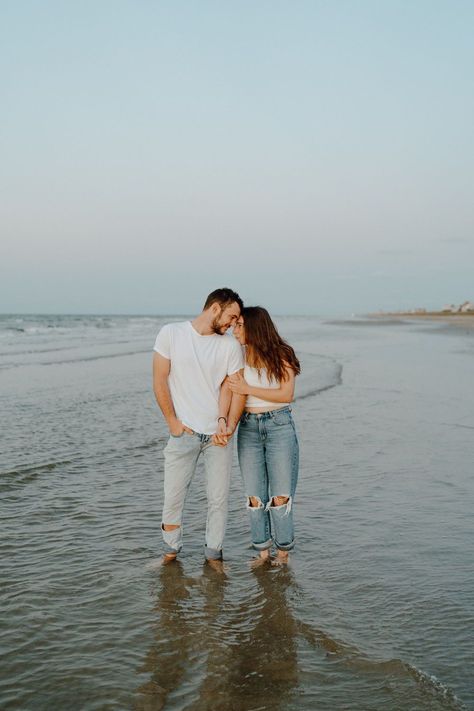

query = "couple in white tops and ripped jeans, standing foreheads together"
[[153, 288, 300, 563]]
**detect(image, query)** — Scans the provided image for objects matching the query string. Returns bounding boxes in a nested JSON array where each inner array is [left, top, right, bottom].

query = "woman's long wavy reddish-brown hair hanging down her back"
[[242, 306, 301, 382]]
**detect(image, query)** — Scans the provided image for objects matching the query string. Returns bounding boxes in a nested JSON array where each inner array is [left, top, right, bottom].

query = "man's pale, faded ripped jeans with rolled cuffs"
[[161, 432, 233, 560]]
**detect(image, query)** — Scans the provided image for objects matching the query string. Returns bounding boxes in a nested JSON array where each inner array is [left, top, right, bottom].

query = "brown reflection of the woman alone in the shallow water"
[[188, 568, 298, 711]]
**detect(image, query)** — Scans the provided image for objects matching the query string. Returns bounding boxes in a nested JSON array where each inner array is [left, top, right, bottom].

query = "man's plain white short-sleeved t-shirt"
[[153, 321, 244, 434]]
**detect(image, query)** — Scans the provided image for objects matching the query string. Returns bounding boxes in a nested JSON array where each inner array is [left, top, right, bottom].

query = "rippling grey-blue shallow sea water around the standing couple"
[[0, 317, 474, 711]]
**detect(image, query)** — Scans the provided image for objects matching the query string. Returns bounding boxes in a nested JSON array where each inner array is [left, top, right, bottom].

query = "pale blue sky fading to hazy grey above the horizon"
[[0, 0, 474, 315]]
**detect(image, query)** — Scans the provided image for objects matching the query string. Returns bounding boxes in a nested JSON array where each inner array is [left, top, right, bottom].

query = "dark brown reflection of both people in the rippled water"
[[135, 561, 298, 711]]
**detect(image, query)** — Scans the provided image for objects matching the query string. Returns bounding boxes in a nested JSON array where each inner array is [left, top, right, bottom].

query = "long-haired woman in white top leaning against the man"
[[227, 306, 300, 564]]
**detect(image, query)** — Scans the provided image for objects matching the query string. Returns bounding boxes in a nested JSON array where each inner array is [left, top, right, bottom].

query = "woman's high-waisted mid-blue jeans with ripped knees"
[[237, 407, 299, 551]]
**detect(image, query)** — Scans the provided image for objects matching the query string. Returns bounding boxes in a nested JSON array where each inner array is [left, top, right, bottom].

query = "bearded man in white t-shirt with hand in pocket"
[[153, 288, 245, 563]]
